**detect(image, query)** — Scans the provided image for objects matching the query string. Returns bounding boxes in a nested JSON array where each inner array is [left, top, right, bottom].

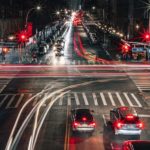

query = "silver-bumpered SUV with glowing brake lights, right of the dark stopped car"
[[110, 107, 144, 137]]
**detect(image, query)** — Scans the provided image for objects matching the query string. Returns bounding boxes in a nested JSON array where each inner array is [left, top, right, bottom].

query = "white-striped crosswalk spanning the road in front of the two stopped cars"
[[0, 91, 145, 109]]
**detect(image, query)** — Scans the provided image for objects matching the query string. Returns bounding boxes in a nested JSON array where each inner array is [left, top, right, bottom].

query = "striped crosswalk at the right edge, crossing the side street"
[[130, 76, 150, 92]]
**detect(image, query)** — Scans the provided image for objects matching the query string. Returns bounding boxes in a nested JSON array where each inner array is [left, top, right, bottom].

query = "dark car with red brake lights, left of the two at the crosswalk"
[[71, 109, 96, 132]]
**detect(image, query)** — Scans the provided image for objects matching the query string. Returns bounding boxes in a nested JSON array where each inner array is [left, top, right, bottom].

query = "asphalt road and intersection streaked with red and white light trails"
[[0, 22, 150, 150]]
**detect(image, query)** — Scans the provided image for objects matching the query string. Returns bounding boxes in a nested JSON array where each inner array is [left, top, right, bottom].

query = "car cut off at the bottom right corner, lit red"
[[122, 140, 150, 150]]
